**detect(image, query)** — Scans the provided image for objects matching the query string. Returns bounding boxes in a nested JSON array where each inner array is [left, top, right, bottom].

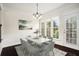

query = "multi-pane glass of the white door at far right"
[[66, 17, 77, 44]]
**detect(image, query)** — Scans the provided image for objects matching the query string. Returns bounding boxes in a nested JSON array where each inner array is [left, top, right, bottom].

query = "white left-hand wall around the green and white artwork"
[[2, 10, 38, 47]]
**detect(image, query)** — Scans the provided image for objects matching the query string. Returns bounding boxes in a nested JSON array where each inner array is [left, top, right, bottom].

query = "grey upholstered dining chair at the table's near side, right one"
[[41, 42, 54, 56]]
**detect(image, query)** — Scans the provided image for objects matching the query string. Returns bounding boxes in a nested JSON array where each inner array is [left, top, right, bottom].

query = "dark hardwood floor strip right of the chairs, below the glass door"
[[55, 44, 79, 56]]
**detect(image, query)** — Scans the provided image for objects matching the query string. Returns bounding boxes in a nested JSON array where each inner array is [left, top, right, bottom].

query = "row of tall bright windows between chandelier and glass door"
[[41, 17, 59, 39]]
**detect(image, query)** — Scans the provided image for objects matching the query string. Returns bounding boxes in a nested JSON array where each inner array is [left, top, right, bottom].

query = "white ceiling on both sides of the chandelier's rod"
[[3, 3, 63, 14]]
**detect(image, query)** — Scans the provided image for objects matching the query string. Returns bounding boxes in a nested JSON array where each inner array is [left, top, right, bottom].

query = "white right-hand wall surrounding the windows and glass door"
[[42, 4, 79, 50]]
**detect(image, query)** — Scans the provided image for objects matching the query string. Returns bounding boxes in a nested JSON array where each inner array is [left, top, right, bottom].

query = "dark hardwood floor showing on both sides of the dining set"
[[1, 44, 79, 56]]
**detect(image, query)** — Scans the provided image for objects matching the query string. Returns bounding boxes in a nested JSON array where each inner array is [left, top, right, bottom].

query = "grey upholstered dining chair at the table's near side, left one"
[[21, 40, 40, 56]]
